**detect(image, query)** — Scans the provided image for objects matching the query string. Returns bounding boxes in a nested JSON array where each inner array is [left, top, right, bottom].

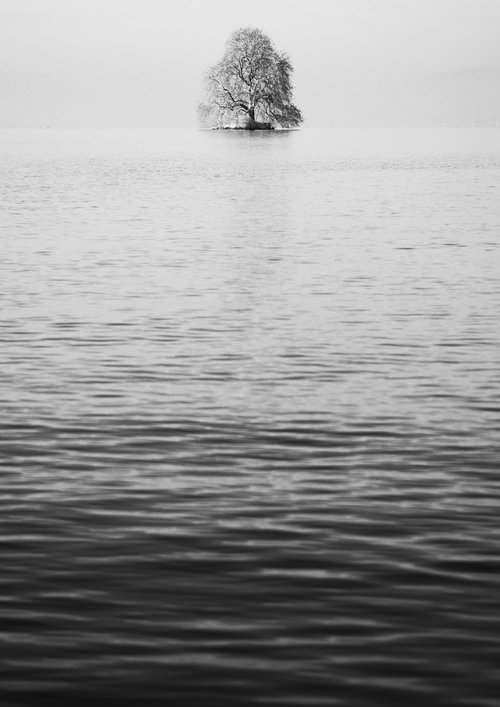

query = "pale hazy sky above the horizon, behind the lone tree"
[[0, 0, 500, 127]]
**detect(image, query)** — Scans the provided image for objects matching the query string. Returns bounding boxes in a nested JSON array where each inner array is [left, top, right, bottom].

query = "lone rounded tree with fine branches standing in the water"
[[198, 27, 302, 130]]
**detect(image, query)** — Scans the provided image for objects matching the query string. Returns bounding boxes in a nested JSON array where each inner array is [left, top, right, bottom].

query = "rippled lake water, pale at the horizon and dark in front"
[[0, 129, 500, 707]]
